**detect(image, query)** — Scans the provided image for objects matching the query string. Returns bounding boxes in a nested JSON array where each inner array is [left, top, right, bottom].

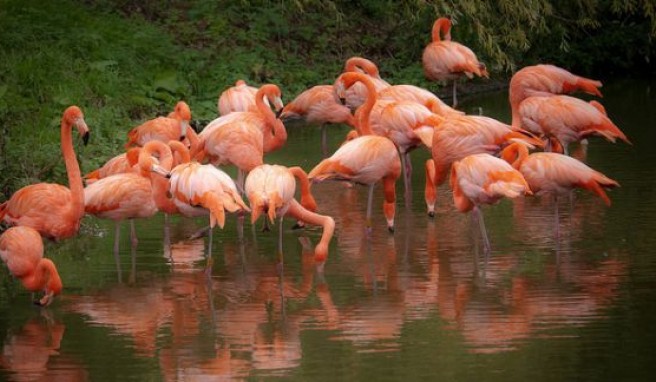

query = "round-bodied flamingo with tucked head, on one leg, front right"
[[451, 154, 532, 253]]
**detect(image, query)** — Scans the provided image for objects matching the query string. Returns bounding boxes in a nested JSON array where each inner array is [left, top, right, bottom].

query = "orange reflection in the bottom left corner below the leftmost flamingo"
[[0, 311, 88, 381]]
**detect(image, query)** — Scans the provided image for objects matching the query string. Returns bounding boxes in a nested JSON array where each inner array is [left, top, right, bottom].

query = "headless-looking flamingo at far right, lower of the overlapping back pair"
[[518, 95, 631, 154]]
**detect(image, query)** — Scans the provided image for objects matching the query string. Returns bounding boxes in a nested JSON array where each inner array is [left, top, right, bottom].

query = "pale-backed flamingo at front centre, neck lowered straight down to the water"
[[308, 135, 401, 232]]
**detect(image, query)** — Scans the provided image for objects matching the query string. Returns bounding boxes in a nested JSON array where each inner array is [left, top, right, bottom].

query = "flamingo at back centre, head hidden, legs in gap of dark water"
[[280, 85, 355, 156]]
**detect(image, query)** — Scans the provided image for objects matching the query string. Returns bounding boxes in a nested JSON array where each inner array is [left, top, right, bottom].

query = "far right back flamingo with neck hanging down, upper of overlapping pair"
[[508, 65, 602, 127]]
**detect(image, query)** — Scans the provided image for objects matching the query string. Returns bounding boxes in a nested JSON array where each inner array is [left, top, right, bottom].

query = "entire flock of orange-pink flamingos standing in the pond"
[[0, 18, 629, 306]]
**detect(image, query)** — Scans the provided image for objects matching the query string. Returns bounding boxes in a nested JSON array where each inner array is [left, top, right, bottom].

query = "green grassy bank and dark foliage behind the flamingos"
[[0, 0, 656, 200]]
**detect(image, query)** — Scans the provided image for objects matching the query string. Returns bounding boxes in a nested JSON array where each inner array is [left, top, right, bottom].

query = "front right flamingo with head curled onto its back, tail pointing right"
[[501, 143, 619, 237]]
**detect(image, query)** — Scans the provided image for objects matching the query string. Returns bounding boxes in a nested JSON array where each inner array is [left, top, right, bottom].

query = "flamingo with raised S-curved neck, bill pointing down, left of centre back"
[[192, 84, 287, 190]]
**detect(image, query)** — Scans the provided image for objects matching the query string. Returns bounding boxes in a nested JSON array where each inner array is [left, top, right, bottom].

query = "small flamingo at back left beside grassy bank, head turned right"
[[125, 101, 191, 149]]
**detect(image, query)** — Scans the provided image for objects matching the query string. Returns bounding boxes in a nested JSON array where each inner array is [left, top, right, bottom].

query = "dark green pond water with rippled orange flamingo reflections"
[[0, 80, 656, 381]]
